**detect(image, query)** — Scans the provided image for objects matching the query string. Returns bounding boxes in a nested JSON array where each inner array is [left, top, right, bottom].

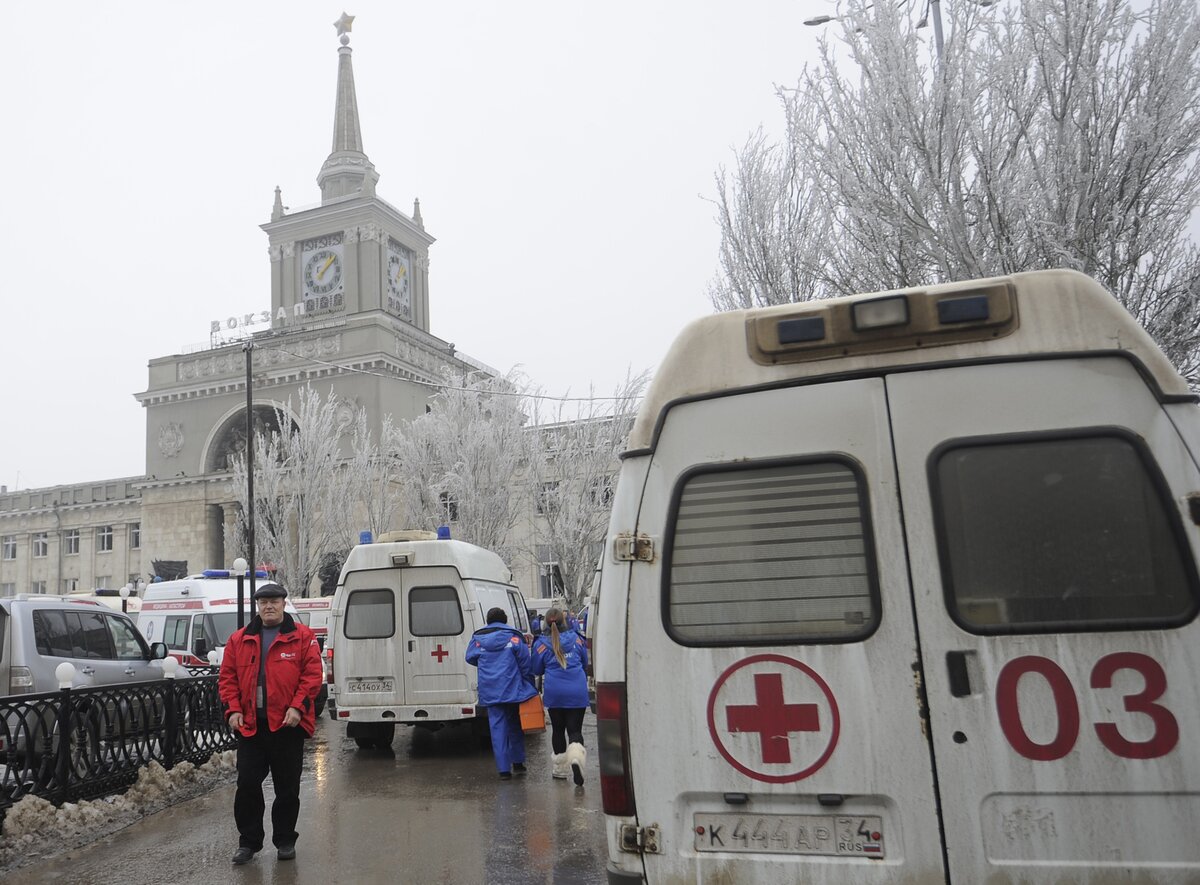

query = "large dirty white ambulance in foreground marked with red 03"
[[595, 271, 1200, 885]]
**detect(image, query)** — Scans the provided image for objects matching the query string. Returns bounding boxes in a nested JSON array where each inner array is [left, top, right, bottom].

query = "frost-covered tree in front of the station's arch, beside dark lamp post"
[[229, 386, 365, 596]]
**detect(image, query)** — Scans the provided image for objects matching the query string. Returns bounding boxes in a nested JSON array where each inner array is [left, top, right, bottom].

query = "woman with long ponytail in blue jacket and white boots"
[[533, 608, 588, 787]]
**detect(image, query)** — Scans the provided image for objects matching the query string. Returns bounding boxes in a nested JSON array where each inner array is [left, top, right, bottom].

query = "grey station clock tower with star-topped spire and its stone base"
[[136, 14, 482, 573]]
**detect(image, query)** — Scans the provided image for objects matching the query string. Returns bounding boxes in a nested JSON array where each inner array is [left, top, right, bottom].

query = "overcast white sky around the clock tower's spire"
[[0, 0, 829, 490]]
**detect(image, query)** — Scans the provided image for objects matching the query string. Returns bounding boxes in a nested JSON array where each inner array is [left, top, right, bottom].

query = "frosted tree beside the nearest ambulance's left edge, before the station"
[[524, 373, 648, 606]]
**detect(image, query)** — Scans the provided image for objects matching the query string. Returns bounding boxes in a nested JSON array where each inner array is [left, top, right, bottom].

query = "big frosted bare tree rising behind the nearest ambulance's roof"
[[710, 0, 1200, 384]]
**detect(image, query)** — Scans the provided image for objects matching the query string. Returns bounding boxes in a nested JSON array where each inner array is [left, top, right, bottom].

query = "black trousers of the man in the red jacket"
[[233, 722, 305, 851]]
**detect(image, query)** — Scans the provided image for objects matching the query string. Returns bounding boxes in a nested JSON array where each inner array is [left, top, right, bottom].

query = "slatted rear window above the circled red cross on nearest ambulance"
[[664, 459, 880, 645]]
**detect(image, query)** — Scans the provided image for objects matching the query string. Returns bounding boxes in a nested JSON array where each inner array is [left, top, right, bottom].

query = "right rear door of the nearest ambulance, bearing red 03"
[[892, 357, 1200, 885]]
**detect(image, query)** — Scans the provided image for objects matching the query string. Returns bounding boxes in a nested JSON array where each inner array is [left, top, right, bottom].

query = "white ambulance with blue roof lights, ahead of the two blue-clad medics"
[[330, 531, 529, 748]]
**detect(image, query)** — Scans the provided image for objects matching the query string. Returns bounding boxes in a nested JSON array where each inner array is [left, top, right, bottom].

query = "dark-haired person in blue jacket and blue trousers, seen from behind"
[[467, 608, 538, 781]]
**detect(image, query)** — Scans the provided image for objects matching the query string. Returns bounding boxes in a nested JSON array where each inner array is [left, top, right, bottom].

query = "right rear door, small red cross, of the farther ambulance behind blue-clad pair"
[[400, 566, 475, 712]]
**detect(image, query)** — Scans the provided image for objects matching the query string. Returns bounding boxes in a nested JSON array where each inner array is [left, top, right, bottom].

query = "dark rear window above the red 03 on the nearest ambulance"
[[931, 431, 1196, 633]]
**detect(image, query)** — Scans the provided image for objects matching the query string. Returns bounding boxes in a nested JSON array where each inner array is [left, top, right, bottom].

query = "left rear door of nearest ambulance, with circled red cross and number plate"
[[625, 379, 944, 885]]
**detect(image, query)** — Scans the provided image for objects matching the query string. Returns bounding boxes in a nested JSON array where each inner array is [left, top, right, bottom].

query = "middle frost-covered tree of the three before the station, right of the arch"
[[385, 371, 528, 551]]
